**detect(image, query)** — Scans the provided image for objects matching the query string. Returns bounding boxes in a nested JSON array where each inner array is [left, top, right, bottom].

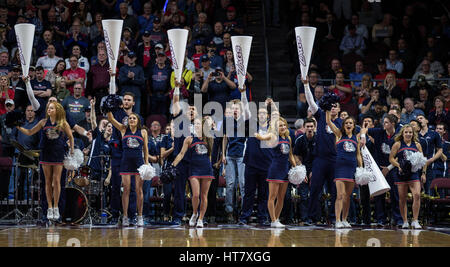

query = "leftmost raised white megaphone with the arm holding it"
[[14, 23, 40, 111]]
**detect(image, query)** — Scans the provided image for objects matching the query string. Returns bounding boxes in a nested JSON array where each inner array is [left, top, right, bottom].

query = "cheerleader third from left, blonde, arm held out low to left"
[[173, 117, 214, 228]]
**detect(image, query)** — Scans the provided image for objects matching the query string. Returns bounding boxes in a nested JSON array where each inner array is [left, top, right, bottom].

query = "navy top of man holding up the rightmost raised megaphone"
[[314, 108, 342, 161]]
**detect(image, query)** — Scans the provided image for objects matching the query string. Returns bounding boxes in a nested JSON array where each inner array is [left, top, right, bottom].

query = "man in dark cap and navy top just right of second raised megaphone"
[[119, 51, 145, 114]]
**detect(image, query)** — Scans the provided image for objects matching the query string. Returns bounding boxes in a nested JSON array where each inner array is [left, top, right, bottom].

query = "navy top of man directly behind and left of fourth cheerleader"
[[244, 123, 272, 171]]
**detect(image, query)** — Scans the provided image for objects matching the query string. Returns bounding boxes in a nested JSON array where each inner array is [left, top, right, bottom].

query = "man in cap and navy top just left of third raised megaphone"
[[150, 52, 172, 115]]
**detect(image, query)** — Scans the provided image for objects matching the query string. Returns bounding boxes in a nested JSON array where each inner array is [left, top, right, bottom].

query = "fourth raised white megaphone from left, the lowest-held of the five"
[[231, 36, 253, 90]]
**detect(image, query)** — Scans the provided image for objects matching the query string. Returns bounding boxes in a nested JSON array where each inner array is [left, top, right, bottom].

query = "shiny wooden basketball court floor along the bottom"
[[0, 225, 450, 248]]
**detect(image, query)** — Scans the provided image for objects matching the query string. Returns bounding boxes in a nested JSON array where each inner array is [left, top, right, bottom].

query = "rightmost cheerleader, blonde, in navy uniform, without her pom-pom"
[[389, 124, 427, 229]]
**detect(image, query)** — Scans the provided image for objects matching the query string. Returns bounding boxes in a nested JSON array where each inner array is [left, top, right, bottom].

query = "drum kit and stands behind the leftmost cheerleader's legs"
[[0, 140, 111, 225]]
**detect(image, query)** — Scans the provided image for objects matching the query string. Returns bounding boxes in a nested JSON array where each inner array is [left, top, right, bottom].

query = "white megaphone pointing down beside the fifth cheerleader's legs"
[[361, 146, 391, 197]]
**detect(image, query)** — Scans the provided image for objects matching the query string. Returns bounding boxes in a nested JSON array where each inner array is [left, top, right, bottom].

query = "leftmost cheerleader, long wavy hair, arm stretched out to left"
[[17, 102, 74, 221]]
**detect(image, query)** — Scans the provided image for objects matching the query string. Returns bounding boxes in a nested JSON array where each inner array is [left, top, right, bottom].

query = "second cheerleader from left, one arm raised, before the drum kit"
[[108, 112, 148, 226]]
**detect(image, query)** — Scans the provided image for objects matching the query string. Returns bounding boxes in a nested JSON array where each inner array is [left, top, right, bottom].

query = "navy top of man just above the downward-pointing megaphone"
[[368, 128, 398, 167]]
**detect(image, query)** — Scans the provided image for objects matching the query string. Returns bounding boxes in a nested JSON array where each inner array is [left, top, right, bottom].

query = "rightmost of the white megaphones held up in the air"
[[295, 26, 316, 80]]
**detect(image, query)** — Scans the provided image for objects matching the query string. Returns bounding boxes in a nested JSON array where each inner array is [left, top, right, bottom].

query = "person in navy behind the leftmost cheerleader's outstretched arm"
[[11, 105, 40, 200]]
